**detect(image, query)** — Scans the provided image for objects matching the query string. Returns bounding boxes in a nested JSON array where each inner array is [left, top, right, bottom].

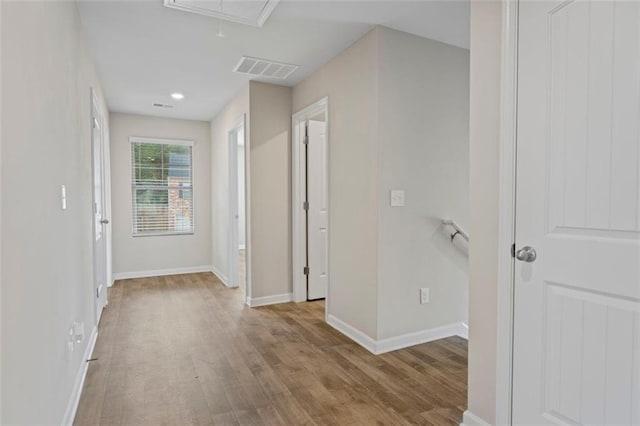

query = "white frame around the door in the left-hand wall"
[[90, 87, 110, 325]]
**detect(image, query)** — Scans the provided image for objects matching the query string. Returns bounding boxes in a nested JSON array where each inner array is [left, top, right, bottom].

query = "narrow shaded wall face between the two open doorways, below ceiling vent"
[[248, 81, 292, 298]]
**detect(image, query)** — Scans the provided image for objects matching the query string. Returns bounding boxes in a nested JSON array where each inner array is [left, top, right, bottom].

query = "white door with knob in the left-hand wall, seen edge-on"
[[91, 98, 109, 324]]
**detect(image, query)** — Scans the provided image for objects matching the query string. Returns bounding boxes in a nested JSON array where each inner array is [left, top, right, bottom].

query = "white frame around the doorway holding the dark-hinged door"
[[291, 97, 331, 313]]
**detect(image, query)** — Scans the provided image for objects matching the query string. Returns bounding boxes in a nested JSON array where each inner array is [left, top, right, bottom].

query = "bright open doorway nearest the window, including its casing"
[[229, 115, 251, 297]]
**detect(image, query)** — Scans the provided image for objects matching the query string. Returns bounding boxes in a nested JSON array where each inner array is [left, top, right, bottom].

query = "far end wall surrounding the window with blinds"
[[110, 113, 211, 279]]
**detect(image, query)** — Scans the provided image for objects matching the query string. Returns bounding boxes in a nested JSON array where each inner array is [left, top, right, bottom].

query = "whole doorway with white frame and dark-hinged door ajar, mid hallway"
[[292, 98, 329, 309]]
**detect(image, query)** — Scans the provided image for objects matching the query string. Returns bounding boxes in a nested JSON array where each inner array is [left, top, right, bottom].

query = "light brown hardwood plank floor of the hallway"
[[75, 273, 467, 425]]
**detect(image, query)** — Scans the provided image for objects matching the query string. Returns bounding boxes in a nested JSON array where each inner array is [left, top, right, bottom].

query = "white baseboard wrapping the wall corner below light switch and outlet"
[[327, 315, 468, 355]]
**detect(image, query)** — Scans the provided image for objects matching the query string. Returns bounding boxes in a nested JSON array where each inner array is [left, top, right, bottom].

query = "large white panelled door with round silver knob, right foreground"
[[513, 0, 640, 425]]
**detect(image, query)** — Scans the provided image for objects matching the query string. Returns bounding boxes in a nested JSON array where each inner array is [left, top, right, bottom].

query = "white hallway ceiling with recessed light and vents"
[[78, 0, 469, 120]]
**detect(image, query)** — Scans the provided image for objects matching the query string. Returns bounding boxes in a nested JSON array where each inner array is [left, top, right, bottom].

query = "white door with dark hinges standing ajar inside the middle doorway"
[[307, 116, 329, 300]]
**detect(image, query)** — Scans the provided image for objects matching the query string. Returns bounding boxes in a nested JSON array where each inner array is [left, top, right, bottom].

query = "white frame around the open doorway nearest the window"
[[227, 114, 251, 300]]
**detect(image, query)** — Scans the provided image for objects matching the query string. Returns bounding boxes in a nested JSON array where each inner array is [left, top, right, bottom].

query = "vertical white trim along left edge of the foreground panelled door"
[[494, 0, 519, 424]]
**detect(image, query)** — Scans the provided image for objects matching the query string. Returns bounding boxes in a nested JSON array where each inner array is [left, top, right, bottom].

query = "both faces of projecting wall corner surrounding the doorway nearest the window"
[[211, 81, 291, 298]]
